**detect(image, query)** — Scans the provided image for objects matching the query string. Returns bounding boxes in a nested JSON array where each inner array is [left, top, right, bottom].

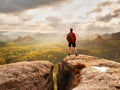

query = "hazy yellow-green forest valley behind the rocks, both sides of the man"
[[0, 33, 120, 64]]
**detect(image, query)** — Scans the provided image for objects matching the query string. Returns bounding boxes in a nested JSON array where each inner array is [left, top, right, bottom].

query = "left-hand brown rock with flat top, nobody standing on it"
[[0, 61, 53, 90]]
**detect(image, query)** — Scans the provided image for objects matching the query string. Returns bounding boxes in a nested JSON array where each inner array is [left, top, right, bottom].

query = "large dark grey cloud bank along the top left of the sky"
[[0, 0, 66, 13]]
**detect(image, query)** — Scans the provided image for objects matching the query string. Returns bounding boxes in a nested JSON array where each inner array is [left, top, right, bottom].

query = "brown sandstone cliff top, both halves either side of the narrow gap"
[[0, 55, 120, 90]]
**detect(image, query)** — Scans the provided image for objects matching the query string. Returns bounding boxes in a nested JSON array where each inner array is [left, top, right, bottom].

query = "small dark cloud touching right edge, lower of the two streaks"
[[97, 13, 120, 22]]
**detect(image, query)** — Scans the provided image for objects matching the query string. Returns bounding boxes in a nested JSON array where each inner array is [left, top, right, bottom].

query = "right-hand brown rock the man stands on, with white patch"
[[57, 55, 120, 90]]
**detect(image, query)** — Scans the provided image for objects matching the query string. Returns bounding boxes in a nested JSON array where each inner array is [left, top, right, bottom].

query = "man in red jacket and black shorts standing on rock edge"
[[66, 28, 78, 56]]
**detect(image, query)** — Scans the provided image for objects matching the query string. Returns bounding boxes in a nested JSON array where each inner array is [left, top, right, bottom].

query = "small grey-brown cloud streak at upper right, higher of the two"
[[90, 1, 113, 13]]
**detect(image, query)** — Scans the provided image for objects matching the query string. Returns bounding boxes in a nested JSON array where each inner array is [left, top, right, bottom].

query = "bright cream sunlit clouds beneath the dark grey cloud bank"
[[0, 0, 120, 33]]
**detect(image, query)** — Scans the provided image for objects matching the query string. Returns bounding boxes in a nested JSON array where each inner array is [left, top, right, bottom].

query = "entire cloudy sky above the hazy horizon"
[[0, 0, 120, 35]]
